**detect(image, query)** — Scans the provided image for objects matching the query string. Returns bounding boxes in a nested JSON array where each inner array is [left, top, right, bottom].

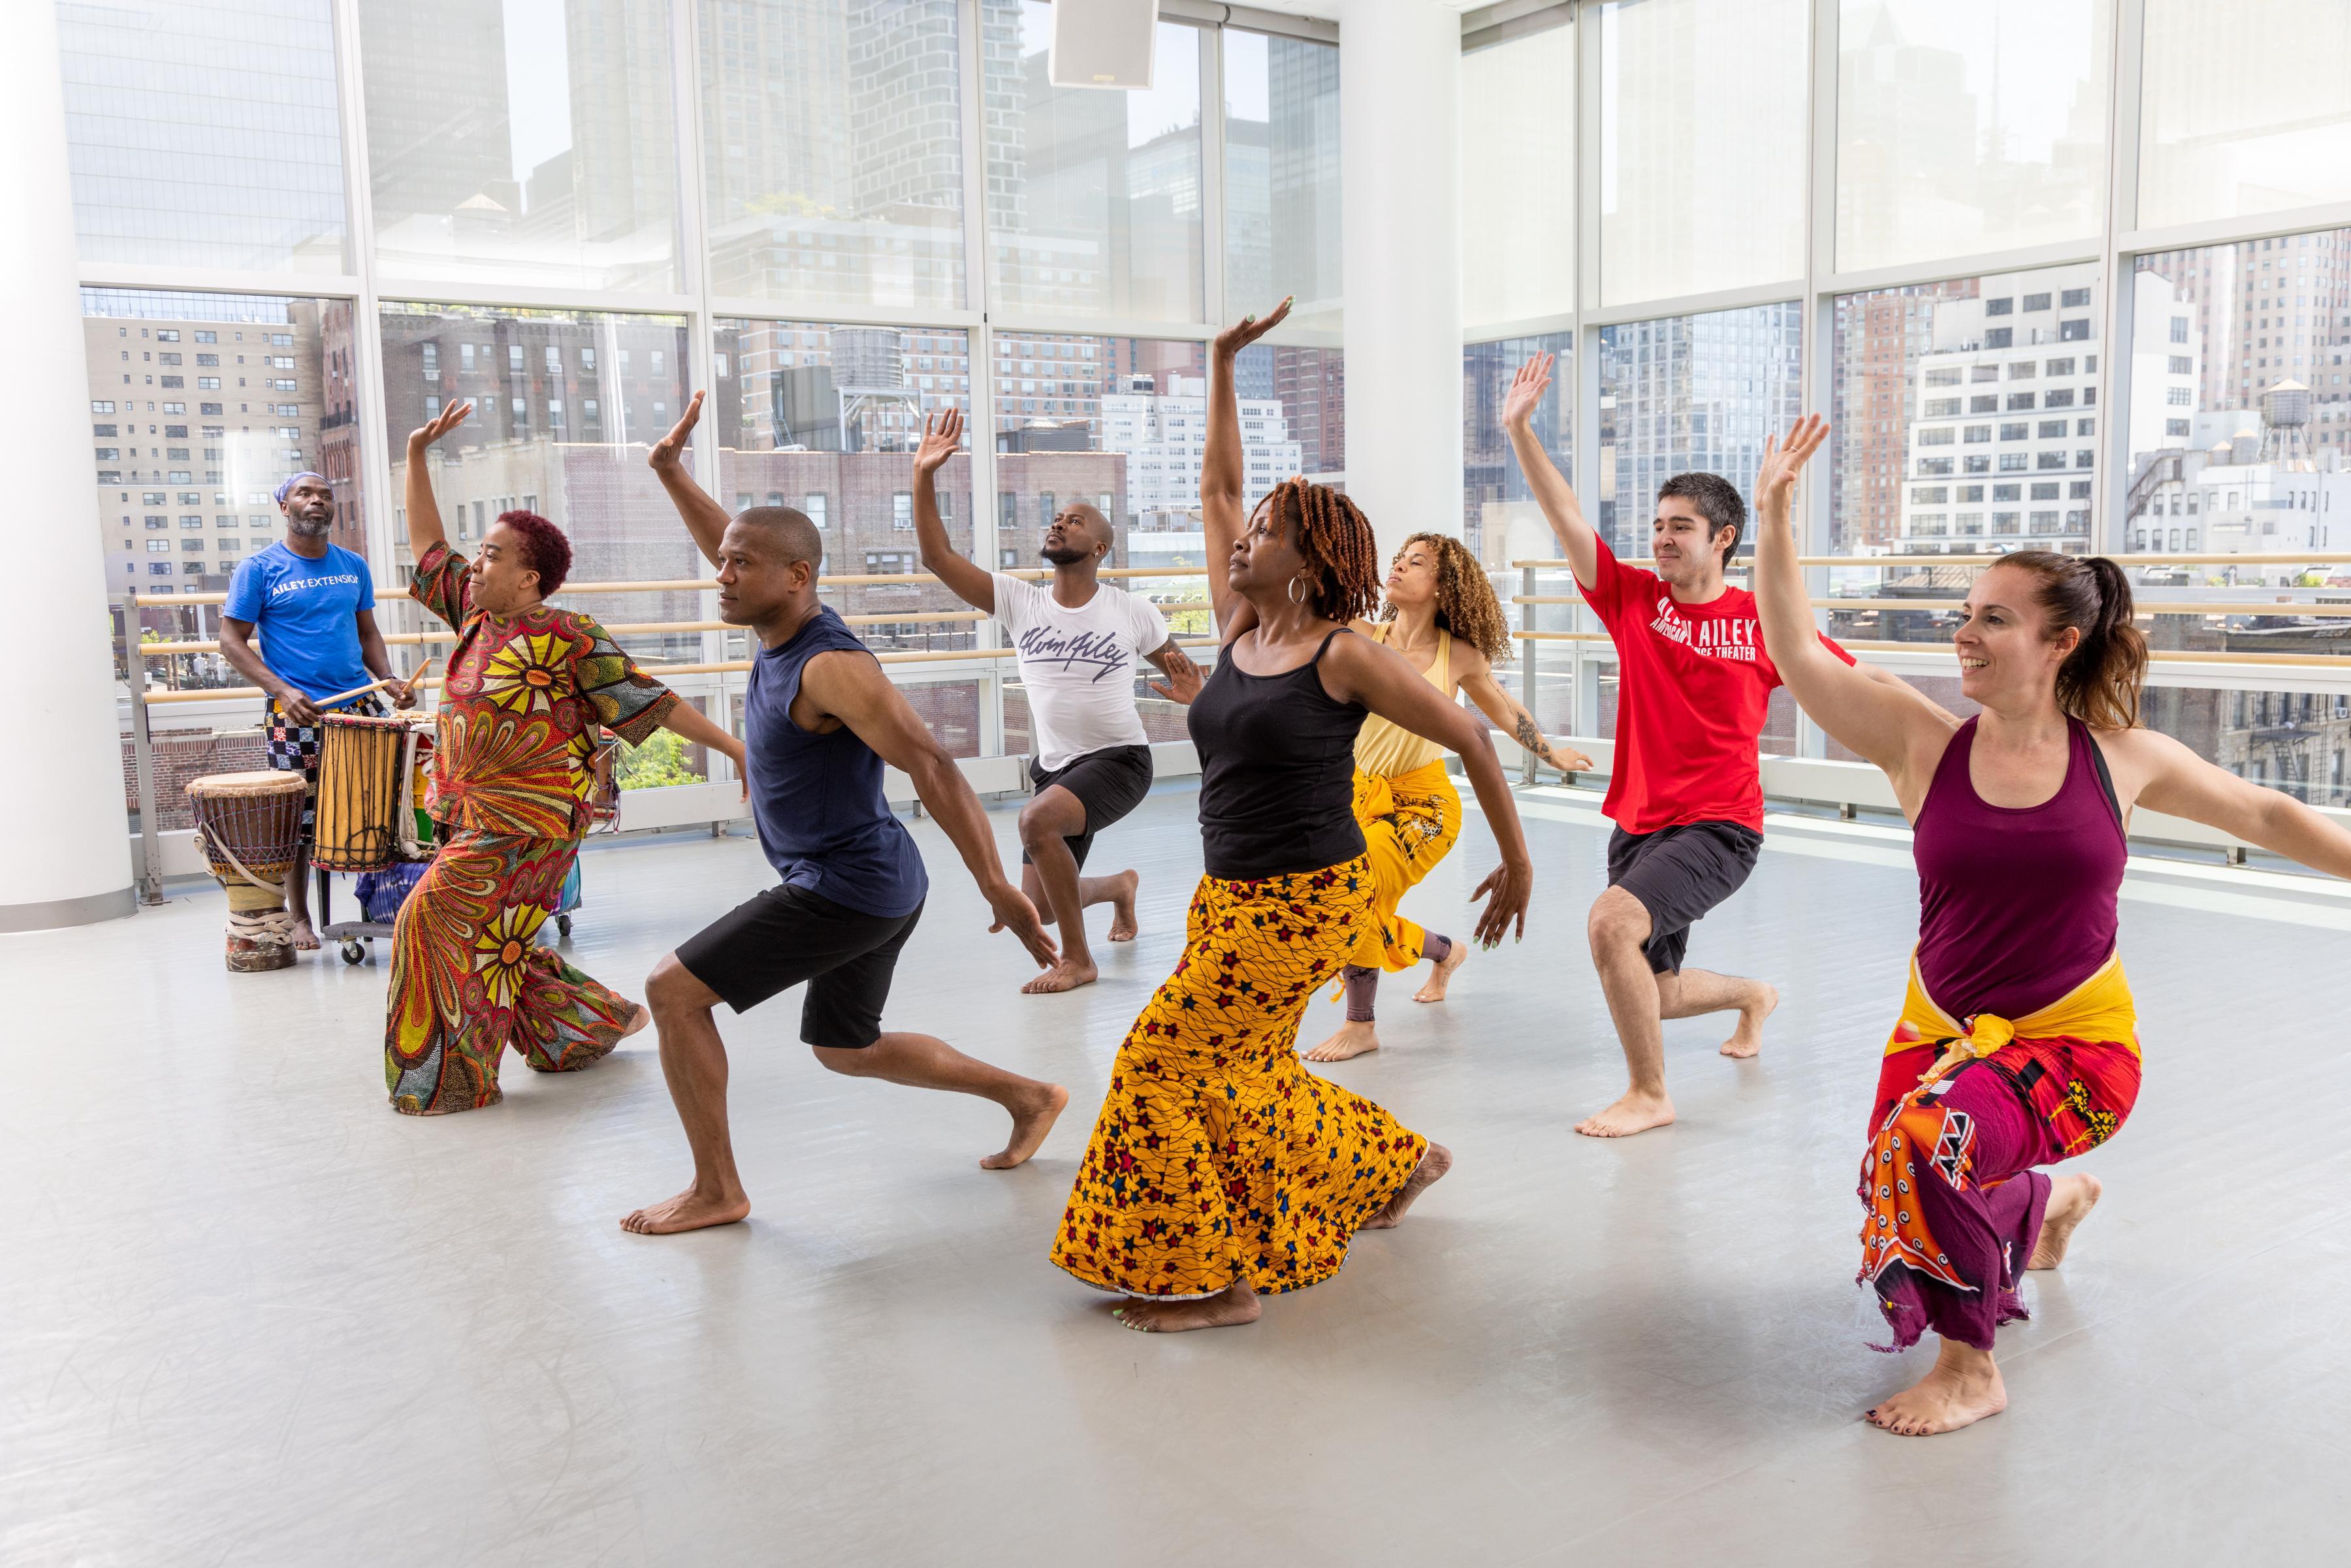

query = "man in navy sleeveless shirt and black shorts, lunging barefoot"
[[620, 395, 1070, 1234]]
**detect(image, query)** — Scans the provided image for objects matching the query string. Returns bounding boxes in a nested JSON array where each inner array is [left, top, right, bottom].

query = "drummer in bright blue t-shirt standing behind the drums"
[[221, 473, 416, 950]]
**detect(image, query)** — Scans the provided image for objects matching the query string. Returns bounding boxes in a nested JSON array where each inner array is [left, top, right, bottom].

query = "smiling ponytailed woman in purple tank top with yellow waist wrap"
[[1756, 416, 2351, 1436]]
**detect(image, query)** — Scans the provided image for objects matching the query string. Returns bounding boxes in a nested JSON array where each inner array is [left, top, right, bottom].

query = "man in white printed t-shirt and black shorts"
[[914, 409, 1202, 995]]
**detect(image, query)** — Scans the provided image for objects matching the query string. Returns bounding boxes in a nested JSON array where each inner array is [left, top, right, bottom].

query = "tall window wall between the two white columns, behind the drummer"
[[56, 0, 1347, 808]]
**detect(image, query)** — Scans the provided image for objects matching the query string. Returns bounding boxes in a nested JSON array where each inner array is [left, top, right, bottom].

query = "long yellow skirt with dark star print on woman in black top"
[[1053, 856, 1430, 1300]]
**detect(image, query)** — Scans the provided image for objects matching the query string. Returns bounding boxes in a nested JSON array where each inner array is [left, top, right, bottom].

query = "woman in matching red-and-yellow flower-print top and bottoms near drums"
[[383, 402, 743, 1117]]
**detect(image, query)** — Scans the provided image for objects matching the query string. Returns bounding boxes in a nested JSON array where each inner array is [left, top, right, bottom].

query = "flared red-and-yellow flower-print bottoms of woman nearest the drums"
[[383, 827, 637, 1117]]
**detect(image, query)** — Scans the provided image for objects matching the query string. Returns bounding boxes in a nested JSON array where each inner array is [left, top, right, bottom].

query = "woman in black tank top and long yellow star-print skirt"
[[1053, 301, 1533, 1333]]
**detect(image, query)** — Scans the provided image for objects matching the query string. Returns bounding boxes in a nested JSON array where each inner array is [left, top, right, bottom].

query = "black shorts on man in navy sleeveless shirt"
[[677, 886, 921, 1051]]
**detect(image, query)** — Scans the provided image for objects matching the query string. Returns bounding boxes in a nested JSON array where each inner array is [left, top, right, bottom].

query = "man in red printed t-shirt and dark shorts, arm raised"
[[1502, 355, 1897, 1138]]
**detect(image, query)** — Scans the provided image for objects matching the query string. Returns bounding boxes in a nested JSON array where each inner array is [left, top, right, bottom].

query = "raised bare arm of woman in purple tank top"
[[1754, 414, 1951, 808]]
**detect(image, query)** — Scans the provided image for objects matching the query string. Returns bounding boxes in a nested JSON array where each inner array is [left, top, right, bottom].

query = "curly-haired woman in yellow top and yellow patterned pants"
[[1305, 534, 1591, 1063]]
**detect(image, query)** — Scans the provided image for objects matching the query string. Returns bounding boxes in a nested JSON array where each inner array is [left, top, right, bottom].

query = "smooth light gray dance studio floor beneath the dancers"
[[0, 785, 2351, 1565]]
